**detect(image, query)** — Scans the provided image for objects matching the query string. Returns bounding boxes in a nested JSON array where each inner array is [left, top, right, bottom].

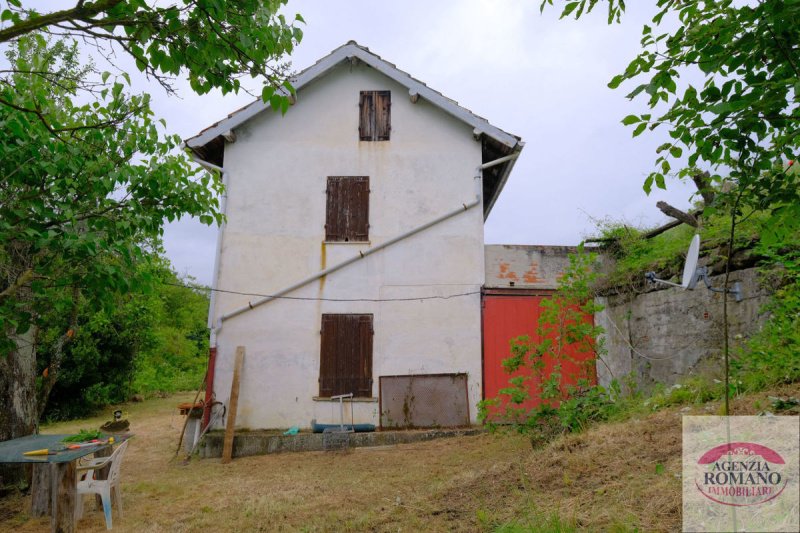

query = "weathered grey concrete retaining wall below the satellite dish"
[[595, 268, 770, 390]]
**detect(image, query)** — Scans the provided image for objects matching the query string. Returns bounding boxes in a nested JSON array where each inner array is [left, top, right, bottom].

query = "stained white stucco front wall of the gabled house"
[[213, 64, 484, 429]]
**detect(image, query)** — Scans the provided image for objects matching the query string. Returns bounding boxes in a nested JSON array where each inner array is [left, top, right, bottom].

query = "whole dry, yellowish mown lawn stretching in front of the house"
[[0, 384, 800, 533]]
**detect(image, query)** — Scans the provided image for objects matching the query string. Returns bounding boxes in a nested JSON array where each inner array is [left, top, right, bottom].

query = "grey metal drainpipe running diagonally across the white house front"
[[216, 153, 519, 331]]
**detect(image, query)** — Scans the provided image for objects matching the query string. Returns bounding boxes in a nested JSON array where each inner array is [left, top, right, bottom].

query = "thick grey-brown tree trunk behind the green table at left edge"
[[0, 327, 38, 486]]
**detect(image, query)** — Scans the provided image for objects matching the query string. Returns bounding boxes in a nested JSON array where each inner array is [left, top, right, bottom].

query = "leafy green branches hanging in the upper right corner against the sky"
[[542, 0, 800, 240]]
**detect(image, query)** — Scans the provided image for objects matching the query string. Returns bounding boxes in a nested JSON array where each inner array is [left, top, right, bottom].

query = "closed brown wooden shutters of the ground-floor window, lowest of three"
[[319, 314, 373, 398]]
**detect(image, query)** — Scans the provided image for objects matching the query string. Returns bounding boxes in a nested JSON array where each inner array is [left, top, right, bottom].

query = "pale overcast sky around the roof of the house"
[[59, 0, 704, 284]]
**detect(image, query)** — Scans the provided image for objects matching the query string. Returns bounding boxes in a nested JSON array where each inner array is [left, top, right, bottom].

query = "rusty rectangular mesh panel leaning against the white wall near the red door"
[[380, 373, 469, 428]]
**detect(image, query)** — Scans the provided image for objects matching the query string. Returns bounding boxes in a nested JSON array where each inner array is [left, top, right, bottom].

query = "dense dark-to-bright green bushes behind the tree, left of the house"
[[42, 254, 208, 419]]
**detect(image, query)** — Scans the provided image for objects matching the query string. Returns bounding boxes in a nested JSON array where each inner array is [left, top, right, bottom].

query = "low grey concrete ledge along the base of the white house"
[[199, 427, 486, 459]]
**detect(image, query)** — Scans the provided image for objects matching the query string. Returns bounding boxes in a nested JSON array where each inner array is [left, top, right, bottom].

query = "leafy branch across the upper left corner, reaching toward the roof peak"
[[0, 0, 303, 103]]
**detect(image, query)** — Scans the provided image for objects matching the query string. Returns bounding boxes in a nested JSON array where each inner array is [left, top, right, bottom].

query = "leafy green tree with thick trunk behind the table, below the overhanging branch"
[[0, 35, 222, 454]]
